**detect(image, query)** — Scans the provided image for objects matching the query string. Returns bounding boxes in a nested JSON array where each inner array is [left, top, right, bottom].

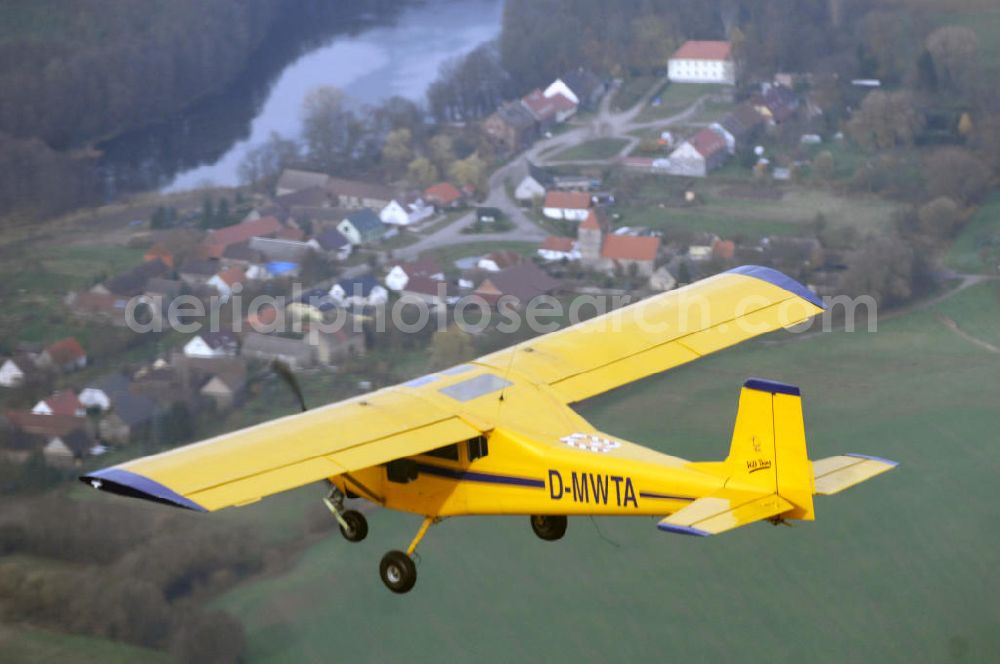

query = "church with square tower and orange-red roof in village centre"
[[576, 210, 660, 276]]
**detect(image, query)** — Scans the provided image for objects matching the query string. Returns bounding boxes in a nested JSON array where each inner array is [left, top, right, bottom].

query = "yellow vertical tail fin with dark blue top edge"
[[725, 378, 813, 520]]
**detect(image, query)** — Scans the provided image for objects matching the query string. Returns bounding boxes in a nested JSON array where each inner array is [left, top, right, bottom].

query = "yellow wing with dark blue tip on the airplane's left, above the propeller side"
[[81, 386, 483, 511]]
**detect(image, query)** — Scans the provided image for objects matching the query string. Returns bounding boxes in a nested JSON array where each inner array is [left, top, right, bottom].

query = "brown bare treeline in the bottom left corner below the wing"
[[0, 496, 265, 662]]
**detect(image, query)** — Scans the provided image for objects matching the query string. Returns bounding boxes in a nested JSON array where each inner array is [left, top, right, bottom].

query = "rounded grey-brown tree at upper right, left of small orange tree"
[[847, 90, 926, 150]]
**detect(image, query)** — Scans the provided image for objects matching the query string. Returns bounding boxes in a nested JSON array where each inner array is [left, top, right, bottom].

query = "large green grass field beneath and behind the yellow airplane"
[[217, 285, 1000, 662]]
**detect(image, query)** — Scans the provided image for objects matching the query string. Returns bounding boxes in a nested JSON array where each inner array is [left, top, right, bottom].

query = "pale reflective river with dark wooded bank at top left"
[[99, 0, 503, 198]]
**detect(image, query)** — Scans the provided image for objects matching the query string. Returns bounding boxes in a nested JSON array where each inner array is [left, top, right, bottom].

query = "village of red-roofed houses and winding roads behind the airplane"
[[0, 41, 952, 468]]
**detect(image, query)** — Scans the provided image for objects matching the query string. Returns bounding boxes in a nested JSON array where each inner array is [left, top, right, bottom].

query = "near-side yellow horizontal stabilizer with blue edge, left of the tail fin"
[[656, 493, 795, 537]]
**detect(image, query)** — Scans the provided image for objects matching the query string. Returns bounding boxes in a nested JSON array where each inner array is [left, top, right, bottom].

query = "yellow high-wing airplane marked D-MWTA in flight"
[[81, 266, 896, 593]]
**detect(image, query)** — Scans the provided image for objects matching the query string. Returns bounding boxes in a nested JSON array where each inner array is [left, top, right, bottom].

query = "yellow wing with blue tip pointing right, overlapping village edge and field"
[[478, 265, 823, 403]]
